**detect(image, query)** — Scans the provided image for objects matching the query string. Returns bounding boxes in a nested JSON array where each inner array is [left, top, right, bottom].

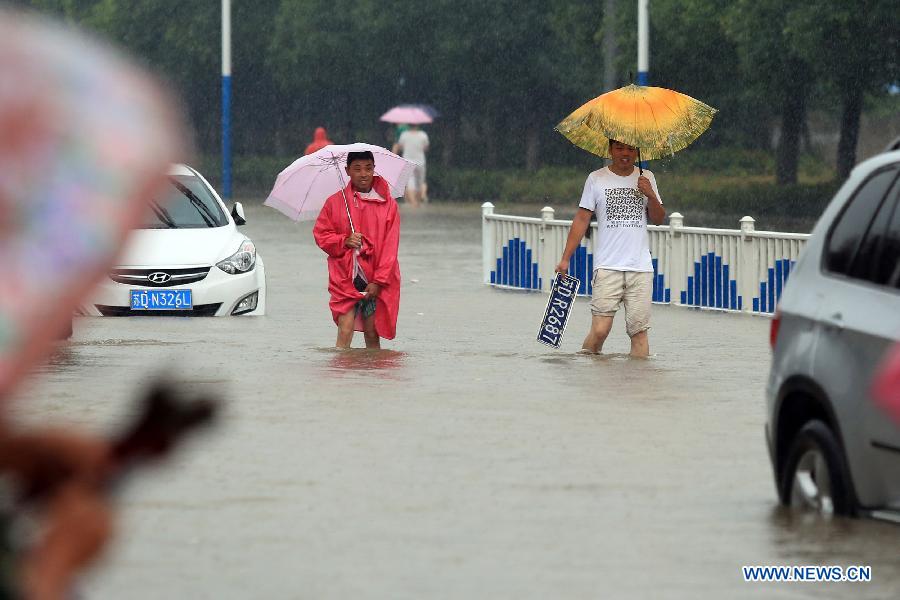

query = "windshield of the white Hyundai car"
[[140, 175, 228, 229]]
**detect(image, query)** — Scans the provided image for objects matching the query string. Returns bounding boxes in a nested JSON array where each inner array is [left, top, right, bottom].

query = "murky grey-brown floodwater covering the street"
[[8, 203, 900, 600]]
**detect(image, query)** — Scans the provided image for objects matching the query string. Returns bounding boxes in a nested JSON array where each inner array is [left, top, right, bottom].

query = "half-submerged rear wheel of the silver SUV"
[[781, 421, 854, 516]]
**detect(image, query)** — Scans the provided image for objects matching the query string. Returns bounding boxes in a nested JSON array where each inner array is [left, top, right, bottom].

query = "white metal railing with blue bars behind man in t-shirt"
[[481, 202, 809, 314]]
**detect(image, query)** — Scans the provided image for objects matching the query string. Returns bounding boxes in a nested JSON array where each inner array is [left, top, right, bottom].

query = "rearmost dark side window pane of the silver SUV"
[[825, 166, 897, 275]]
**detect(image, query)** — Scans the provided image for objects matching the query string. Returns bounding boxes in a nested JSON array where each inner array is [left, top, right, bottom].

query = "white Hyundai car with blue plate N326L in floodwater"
[[80, 165, 266, 317]]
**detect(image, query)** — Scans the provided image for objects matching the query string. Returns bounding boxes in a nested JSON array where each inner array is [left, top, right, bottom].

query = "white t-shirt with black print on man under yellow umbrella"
[[578, 167, 662, 273]]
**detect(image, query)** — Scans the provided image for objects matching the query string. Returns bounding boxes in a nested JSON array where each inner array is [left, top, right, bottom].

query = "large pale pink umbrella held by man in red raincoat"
[[263, 142, 416, 227]]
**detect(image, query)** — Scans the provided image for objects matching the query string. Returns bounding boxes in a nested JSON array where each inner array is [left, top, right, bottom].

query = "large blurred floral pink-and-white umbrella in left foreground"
[[0, 10, 184, 397]]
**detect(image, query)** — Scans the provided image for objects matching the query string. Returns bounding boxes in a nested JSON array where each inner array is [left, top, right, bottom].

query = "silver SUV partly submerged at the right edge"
[[766, 151, 900, 522]]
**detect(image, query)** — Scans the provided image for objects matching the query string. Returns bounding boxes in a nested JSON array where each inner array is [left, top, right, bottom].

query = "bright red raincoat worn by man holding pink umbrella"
[[313, 176, 400, 340]]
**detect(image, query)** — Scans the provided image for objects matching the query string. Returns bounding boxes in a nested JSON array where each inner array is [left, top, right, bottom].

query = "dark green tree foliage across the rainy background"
[[15, 0, 900, 182]]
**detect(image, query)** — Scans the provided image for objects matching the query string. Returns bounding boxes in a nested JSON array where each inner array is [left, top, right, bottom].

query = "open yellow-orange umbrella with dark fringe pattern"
[[556, 85, 718, 160]]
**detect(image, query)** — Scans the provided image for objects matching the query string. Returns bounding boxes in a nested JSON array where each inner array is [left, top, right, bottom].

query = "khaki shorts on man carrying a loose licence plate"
[[591, 269, 653, 337]]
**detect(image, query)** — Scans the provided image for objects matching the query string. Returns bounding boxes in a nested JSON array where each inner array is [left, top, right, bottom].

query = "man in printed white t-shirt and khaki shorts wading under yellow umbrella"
[[556, 140, 666, 357]]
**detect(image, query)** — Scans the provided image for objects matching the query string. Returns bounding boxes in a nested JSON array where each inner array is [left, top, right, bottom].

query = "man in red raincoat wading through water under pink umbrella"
[[313, 152, 400, 348]]
